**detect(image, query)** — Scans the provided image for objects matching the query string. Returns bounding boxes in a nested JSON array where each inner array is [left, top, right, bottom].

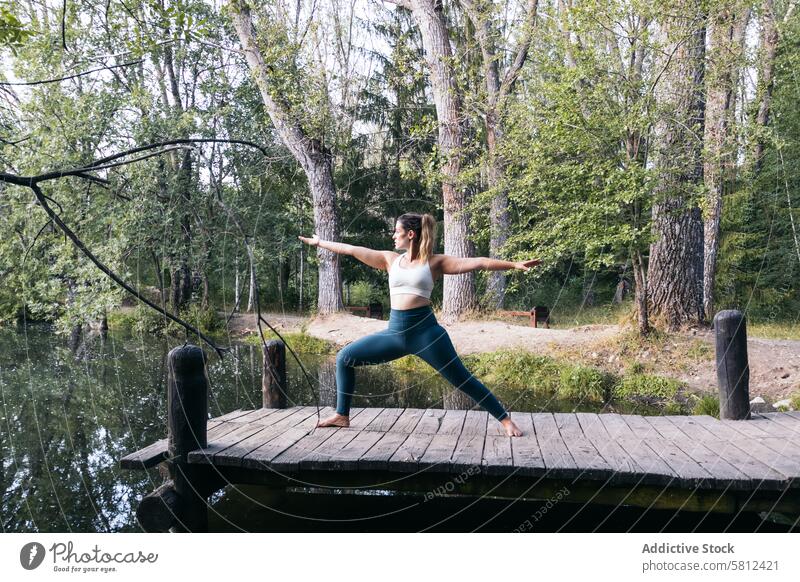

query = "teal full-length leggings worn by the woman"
[[336, 305, 508, 420]]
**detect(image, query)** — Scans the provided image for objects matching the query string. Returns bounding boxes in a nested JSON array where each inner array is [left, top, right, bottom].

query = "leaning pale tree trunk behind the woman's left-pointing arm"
[[231, 0, 343, 313]]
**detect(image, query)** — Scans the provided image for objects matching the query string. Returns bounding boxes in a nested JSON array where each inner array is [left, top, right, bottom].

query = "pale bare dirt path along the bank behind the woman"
[[230, 313, 800, 403]]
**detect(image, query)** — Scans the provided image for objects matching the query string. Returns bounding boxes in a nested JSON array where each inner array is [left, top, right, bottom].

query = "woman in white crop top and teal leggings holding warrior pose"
[[298, 213, 541, 436]]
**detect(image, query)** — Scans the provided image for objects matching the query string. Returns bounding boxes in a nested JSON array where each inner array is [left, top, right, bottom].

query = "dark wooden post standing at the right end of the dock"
[[714, 309, 750, 420]]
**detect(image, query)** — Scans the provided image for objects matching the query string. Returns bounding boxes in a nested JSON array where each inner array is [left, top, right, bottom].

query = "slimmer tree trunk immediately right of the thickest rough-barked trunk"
[[703, 5, 750, 321]]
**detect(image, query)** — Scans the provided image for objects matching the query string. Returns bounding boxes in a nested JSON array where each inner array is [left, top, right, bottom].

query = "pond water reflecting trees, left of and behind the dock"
[[0, 327, 712, 532]]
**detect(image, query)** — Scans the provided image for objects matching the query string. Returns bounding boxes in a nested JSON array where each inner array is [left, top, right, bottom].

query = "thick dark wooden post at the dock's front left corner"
[[167, 345, 208, 532]]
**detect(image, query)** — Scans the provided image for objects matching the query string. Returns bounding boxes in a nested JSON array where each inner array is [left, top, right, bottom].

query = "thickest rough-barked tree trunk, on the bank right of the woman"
[[647, 0, 705, 329]]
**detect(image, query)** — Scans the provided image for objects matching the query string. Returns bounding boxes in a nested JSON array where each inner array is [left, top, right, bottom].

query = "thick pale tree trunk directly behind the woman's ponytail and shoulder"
[[408, 0, 477, 321]]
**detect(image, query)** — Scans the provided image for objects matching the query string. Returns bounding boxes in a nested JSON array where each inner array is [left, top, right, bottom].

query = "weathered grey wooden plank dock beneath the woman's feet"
[[121, 406, 800, 515]]
